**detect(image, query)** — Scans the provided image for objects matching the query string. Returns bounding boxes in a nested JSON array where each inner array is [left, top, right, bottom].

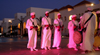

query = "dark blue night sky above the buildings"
[[0, 0, 99, 20]]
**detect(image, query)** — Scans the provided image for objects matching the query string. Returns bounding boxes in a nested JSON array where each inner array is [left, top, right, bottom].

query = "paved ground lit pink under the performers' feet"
[[0, 38, 100, 55]]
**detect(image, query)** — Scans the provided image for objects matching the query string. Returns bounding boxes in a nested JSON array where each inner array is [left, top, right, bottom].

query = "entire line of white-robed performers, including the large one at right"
[[26, 7, 100, 51]]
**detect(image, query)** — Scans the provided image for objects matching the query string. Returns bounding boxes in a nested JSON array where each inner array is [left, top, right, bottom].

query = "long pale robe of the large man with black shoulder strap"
[[81, 12, 96, 51]]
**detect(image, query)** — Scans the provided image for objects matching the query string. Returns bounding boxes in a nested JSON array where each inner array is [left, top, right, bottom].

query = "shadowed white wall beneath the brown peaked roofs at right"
[[59, 5, 98, 35]]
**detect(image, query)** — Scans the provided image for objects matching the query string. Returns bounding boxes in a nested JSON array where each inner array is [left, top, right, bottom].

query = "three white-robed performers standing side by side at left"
[[26, 11, 64, 51]]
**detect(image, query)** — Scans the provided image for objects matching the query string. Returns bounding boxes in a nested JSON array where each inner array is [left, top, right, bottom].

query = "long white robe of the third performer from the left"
[[53, 18, 63, 47]]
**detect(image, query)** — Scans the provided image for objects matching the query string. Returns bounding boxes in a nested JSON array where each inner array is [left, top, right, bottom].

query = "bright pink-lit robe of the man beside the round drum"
[[68, 20, 79, 48]]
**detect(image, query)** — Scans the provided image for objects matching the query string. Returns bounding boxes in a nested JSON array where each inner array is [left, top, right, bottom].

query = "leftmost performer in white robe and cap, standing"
[[26, 12, 37, 51]]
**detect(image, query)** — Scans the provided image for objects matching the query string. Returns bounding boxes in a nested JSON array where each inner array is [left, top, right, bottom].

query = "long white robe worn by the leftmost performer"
[[26, 18, 37, 48]]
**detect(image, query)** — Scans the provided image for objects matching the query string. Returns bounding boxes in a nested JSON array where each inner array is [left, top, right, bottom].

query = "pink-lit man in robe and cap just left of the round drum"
[[67, 15, 79, 51]]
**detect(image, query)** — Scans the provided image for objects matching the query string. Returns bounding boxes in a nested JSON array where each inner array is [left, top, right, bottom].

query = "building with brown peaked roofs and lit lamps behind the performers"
[[50, 0, 100, 35]]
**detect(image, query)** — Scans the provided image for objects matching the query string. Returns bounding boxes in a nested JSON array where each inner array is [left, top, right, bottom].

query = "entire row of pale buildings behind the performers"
[[1, 0, 100, 35]]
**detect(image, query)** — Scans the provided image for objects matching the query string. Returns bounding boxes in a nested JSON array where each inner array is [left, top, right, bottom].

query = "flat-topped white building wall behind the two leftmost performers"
[[23, 7, 52, 33]]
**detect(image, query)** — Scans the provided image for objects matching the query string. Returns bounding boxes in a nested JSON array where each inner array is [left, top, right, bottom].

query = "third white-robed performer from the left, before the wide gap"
[[52, 13, 63, 49]]
